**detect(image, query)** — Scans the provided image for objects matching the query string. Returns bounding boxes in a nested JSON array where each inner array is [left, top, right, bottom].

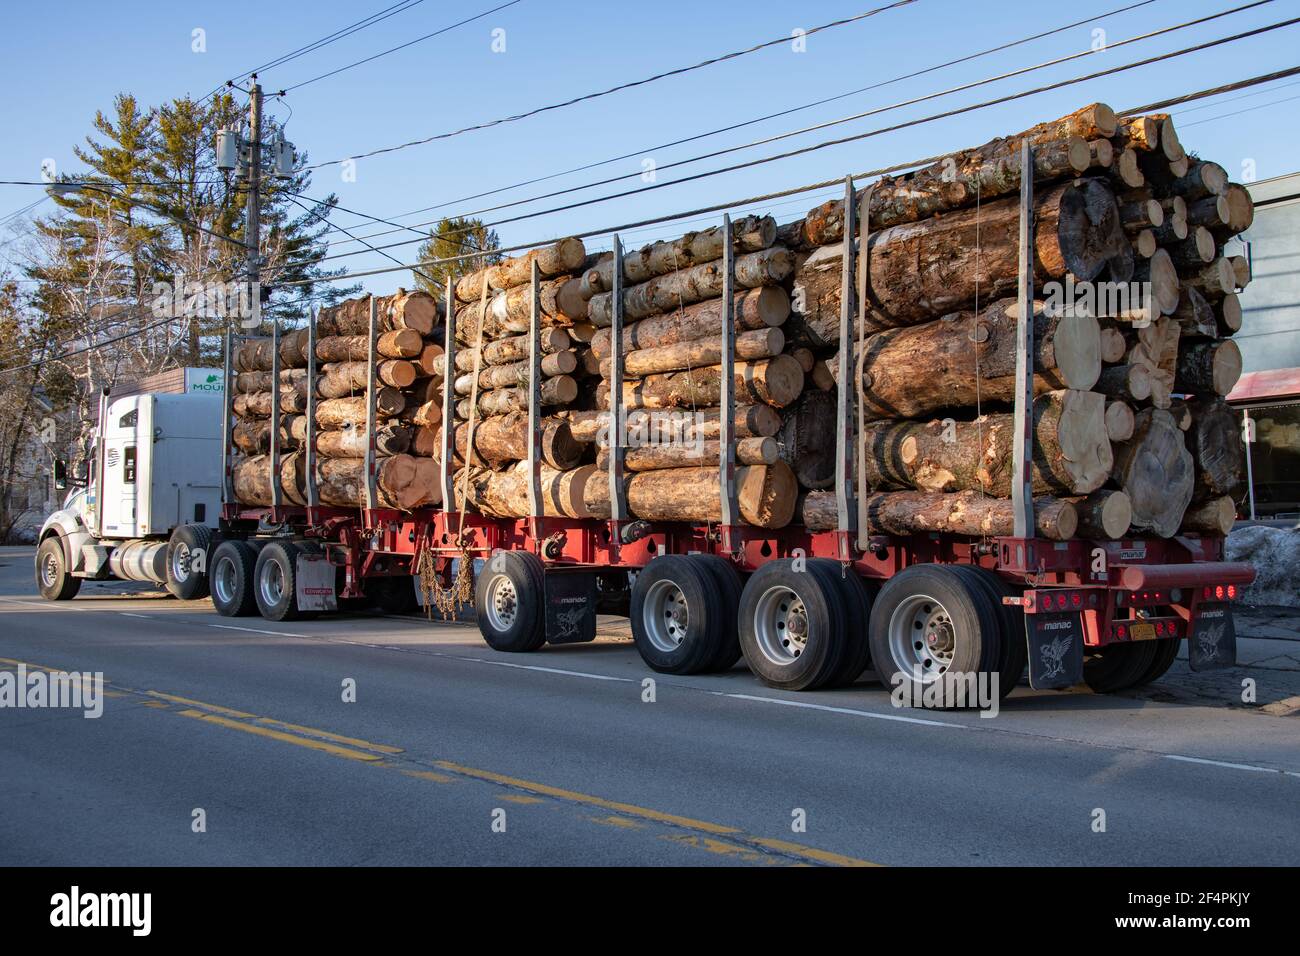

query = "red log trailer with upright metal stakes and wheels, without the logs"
[[40, 149, 1255, 695]]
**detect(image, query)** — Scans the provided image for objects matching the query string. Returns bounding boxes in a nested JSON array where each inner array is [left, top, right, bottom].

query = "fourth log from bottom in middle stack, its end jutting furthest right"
[[597, 355, 803, 408]]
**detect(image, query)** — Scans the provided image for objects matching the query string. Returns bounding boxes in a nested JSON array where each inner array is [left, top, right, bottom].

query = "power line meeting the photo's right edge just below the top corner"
[[312, 17, 1300, 269]]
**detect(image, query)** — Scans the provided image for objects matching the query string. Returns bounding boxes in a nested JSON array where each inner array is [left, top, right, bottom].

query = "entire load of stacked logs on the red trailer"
[[237, 104, 1252, 540]]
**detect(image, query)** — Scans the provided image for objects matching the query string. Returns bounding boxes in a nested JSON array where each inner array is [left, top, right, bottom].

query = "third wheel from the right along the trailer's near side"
[[628, 554, 728, 674]]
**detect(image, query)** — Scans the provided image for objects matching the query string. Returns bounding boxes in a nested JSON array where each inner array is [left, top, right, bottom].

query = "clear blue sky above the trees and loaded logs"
[[0, 0, 1300, 291]]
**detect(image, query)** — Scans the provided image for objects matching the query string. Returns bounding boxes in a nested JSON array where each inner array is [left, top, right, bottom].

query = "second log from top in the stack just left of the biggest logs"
[[586, 246, 794, 328]]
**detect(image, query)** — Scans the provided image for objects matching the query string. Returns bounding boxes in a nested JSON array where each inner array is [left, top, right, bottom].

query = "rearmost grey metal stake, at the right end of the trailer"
[[1011, 139, 1036, 538]]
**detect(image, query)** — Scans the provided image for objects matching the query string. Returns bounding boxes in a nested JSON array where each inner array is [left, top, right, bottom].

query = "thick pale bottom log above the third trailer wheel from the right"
[[586, 462, 798, 528]]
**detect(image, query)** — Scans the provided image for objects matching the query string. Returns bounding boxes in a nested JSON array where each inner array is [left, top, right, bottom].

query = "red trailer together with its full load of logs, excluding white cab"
[[38, 104, 1255, 700]]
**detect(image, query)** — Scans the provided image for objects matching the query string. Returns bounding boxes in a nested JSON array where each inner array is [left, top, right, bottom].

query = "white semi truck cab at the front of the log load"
[[36, 393, 225, 601]]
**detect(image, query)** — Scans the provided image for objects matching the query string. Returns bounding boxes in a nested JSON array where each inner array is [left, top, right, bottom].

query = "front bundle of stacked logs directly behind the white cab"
[[231, 289, 452, 510]]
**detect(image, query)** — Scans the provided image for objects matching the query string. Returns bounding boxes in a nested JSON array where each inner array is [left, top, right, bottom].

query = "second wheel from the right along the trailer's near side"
[[740, 561, 849, 691]]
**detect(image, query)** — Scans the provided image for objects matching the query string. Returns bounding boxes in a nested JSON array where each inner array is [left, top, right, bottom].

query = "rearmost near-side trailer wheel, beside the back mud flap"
[[870, 564, 1004, 700]]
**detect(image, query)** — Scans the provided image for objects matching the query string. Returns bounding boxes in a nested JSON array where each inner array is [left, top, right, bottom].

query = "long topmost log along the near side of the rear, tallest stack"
[[779, 103, 1117, 250]]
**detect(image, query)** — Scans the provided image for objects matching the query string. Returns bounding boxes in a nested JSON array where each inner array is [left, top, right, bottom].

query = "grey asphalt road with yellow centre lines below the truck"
[[0, 549, 1300, 866]]
